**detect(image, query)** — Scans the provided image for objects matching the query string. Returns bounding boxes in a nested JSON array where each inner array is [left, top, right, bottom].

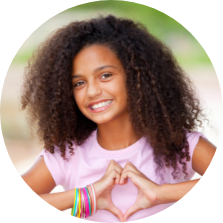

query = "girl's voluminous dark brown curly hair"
[[21, 15, 205, 179]]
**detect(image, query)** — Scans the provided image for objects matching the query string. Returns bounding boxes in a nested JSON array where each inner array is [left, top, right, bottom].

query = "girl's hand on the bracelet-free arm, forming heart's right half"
[[120, 162, 160, 222]]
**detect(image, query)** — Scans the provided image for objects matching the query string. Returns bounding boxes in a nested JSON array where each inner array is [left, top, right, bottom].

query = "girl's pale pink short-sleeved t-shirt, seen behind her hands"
[[37, 130, 206, 223]]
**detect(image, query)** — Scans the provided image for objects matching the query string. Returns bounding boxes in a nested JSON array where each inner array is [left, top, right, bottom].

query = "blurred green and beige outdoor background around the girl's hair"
[[0, 0, 220, 177]]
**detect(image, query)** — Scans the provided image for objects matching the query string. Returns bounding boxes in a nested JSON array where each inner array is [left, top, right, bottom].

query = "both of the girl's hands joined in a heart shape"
[[95, 160, 159, 223]]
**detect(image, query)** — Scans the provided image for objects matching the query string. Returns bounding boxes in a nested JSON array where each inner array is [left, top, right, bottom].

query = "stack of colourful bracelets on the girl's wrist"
[[71, 184, 97, 218]]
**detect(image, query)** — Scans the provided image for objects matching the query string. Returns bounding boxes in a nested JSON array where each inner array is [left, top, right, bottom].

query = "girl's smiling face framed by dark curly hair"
[[72, 45, 128, 124]]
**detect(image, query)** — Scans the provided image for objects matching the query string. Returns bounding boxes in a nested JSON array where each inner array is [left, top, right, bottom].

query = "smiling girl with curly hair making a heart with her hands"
[[21, 15, 216, 223]]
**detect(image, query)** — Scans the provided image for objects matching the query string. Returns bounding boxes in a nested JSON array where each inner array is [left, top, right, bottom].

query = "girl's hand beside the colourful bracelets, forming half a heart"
[[93, 160, 128, 222]]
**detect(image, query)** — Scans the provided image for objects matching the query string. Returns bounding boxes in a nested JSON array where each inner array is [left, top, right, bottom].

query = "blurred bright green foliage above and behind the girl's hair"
[[12, 0, 211, 65]]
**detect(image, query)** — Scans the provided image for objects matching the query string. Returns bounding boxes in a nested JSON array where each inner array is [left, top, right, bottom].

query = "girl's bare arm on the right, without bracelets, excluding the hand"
[[157, 137, 217, 204]]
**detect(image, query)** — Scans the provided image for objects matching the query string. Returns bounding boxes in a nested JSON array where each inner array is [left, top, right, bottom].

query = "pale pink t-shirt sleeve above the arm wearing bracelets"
[[36, 150, 64, 186]]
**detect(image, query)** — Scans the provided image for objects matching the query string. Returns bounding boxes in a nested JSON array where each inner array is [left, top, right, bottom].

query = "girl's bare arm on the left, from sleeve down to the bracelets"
[[21, 156, 92, 211]]
